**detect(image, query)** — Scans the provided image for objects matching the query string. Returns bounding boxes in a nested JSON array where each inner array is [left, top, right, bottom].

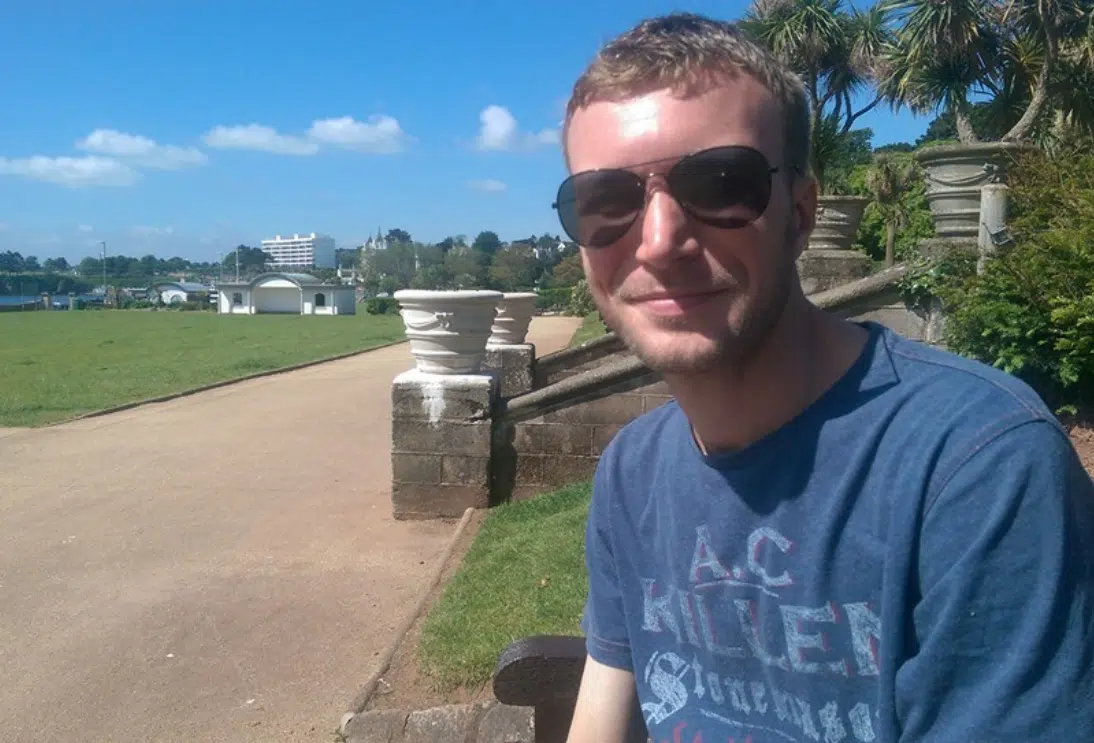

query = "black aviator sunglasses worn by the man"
[[551, 146, 798, 247]]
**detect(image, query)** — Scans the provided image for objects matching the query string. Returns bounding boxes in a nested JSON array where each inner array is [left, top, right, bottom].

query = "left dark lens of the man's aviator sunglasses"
[[557, 170, 645, 247]]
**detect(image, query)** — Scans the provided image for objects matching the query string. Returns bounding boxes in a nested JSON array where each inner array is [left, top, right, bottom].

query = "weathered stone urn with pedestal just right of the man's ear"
[[798, 196, 870, 294]]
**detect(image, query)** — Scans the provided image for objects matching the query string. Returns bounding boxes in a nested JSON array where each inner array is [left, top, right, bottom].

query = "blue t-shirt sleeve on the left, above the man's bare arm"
[[581, 445, 633, 671]]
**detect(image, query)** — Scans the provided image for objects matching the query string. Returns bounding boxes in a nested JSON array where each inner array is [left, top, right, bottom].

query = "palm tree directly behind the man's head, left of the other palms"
[[740, 0, 893, 193]]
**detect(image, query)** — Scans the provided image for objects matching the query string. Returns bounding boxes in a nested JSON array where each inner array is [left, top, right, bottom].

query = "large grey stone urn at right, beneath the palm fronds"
[[915, 142, 1028, 244]]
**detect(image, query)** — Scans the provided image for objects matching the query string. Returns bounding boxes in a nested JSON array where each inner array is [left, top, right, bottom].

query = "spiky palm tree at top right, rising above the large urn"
[[878, 0, 1094, 144]]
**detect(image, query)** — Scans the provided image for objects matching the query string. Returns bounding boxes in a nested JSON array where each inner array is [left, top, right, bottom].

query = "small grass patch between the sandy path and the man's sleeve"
[[418, 483, 592, 692]]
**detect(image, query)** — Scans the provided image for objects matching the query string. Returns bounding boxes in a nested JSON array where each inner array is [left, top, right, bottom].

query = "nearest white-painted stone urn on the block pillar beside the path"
[[395, 289, 502, 374]]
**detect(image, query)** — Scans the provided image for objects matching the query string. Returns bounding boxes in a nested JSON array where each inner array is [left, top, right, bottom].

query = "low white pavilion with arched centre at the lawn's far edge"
[[217, 274, 357, 315]]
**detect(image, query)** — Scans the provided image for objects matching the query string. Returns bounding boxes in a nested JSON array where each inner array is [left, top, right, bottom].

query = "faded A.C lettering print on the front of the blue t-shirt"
[[635, 525, 881, 743]]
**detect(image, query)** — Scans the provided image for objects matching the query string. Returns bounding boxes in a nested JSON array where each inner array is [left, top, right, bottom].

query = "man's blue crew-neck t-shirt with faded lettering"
[[583, 323, 1094, 743]]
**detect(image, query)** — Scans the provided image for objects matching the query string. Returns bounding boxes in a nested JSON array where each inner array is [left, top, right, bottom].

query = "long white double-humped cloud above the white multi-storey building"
[[202, 115, 414, 155]]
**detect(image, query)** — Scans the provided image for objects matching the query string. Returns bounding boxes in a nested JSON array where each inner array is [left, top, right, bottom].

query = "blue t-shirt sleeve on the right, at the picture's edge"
[[895, 420, 1094, 743]]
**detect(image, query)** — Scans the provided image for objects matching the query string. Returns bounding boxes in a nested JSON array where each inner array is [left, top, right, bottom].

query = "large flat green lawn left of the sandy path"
[[0, 310, 403, 426]]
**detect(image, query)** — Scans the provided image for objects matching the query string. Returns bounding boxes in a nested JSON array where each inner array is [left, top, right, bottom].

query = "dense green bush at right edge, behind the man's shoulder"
[[938, 149, 1094, 411]]
